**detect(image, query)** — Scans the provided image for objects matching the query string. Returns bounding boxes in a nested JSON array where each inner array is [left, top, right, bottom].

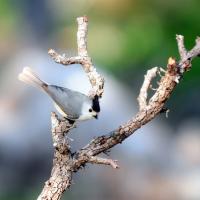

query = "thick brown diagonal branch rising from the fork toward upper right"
[[74, 34, 200, 173]]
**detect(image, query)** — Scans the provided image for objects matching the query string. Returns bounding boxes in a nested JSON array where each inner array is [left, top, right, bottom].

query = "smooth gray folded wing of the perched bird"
[[46, 85, 90, 119]]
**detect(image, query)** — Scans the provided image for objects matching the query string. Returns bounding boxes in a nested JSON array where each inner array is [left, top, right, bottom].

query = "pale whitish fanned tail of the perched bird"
[[18, 67, 48, 89]]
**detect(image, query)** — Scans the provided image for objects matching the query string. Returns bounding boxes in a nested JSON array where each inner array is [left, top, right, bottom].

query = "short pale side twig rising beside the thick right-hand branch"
[[138, 67, 158, 111]]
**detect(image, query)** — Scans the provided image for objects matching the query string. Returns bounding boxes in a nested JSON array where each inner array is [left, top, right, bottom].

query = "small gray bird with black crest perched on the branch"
[[18, 67, 100, 121]]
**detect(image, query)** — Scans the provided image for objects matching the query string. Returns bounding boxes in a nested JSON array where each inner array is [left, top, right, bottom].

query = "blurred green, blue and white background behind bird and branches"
[[0, 0, 200, 200]]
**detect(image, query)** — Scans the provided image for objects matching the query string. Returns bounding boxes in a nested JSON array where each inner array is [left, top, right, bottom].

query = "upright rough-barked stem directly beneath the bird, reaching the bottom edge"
[[37, 113, 73, 200]]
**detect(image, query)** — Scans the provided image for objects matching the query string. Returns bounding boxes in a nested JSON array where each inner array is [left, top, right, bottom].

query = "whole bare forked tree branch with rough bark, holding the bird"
[[38, 16, 200, 200]]
